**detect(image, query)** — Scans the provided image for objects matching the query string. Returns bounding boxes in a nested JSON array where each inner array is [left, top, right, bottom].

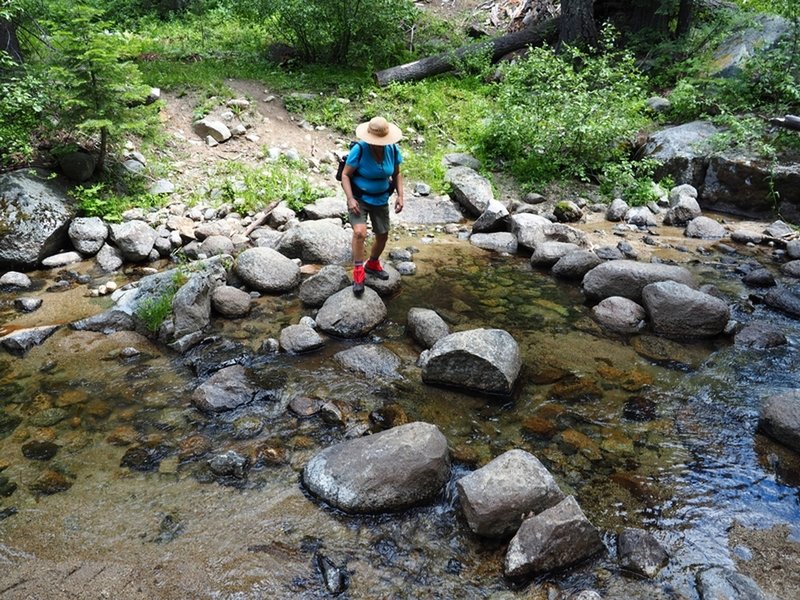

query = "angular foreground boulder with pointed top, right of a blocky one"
[[505, 496, 604, 578]]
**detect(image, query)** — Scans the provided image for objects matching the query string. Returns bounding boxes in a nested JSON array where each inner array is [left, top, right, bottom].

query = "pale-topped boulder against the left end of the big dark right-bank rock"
[[644, 121, 719, 190]]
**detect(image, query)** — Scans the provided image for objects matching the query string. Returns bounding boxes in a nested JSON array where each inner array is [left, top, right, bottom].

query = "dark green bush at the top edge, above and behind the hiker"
[[248, 0, 415, 65]]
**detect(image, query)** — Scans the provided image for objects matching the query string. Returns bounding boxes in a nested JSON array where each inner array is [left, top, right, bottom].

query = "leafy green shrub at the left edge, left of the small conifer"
[[0, 51, 46, 165]]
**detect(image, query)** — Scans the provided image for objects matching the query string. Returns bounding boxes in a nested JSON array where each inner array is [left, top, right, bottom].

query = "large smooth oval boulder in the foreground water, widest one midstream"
[[303, 422, 450, 513]]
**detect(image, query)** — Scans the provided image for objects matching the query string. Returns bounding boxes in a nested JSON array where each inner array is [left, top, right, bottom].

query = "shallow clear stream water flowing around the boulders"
[[0, 245, 800, 598]]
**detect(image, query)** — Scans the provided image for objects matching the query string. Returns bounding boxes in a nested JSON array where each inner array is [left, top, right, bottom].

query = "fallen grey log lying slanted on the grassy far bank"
[[373, 19, 558, 87]]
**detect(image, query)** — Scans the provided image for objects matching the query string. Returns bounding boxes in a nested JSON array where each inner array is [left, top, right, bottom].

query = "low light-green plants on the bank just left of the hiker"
[[193, 158, 327, 213]]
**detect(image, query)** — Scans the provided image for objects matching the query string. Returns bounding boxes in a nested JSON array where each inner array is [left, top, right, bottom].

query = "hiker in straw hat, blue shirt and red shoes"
[[342, 117, 403, 296]]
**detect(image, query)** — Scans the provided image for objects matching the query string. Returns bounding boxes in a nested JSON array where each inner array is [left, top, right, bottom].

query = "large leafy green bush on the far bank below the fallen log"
[[482, 27, 648, 185]]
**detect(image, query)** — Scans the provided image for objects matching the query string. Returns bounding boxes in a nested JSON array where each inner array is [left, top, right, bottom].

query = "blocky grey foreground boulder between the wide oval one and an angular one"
[[456, 450, 564, 537]]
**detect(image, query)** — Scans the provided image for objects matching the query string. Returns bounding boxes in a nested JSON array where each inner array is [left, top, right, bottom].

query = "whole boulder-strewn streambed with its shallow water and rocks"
[[0, 162, 800, 599]]
